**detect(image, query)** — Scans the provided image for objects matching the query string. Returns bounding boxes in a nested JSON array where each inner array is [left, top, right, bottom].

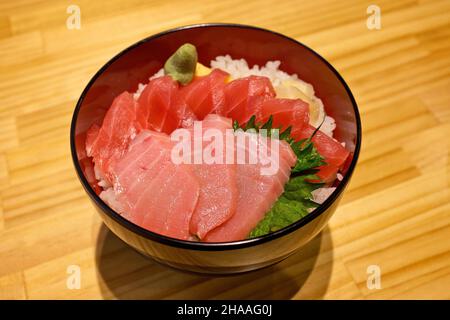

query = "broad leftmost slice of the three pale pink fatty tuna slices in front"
[[105, 130, 200, 240]]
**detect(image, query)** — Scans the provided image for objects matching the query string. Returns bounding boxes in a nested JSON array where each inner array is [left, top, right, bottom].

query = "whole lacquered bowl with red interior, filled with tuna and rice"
[[70, 24, 361, 274]]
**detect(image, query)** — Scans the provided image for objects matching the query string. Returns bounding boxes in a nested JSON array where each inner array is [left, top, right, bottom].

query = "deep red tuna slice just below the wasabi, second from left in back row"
[[136, 76, 195, 134]]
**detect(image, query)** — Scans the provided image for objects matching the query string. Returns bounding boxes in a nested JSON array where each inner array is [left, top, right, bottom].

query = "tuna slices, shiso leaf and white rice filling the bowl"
[[86, 42, 350, 242]]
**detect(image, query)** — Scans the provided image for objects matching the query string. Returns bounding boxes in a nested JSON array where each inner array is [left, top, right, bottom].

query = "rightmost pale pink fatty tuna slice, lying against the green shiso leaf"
[[204, 131, 296, 242]]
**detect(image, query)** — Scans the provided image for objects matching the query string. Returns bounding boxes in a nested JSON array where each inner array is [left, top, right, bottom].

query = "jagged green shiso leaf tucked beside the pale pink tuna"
[[233, 116, 326, 238]]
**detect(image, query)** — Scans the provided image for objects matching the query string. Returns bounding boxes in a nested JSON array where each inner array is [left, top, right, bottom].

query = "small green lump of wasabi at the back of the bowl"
[[164, 43, 197, 85]]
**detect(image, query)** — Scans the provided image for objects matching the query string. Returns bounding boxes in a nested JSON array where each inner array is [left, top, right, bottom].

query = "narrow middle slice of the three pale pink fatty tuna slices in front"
[[174, 114, 238, 239]]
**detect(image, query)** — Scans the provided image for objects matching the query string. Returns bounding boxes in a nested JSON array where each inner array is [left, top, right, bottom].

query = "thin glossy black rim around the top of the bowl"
[[70, 23, 362, 251]]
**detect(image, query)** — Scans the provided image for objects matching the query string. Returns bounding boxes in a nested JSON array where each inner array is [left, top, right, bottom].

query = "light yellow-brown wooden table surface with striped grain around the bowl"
[[0, 0, 450, 299]]
